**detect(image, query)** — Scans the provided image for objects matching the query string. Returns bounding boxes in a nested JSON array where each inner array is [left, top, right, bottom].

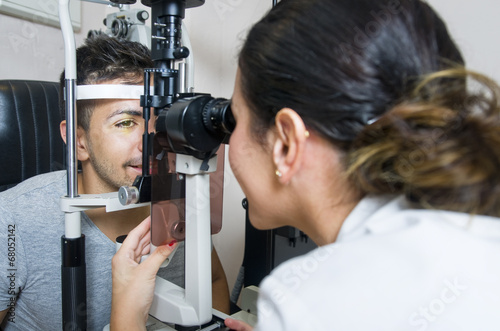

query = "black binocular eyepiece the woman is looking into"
[[156, 94, 236, 159]]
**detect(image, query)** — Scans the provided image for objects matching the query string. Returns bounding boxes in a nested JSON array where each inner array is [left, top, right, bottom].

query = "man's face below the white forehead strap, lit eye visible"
[[84, 99, 153, 192]]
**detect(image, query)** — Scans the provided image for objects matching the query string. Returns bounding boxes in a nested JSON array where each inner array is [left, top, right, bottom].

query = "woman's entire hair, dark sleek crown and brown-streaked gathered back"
[[239, 0, 500, 215]]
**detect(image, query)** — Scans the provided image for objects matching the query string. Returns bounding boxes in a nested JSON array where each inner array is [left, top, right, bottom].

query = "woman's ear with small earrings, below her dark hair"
[[273, 108, 309, 184]]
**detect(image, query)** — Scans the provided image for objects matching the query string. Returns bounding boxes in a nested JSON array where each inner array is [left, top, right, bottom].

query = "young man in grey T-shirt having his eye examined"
[[0, 35, 229, 330]]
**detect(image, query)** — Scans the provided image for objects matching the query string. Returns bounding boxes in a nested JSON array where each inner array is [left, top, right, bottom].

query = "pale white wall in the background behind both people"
[[0, 0, 500, 294]]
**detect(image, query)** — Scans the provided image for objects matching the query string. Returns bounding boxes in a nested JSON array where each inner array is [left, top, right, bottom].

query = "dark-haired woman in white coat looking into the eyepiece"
[[111, 0, 500, 330]]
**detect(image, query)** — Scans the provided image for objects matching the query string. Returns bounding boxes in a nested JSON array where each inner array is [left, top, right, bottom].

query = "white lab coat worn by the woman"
[[255, 197, 500, 331]]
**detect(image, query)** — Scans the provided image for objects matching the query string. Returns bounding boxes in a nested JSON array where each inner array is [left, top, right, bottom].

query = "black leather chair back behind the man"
[[0, 80, 65, 191]]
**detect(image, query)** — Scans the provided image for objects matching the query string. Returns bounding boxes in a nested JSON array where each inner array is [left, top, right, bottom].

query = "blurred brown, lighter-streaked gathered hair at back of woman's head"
[[346, 69, 500, 216]]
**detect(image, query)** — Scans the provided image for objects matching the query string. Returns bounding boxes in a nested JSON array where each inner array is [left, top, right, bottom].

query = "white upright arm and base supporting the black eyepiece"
[[149, 154, 213, 325]]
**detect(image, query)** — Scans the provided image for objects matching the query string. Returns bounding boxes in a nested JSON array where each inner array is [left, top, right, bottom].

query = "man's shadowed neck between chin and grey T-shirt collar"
[[78, 174, 150, 241]]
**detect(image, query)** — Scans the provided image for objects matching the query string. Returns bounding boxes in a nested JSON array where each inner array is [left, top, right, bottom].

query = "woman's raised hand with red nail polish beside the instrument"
[[110, 217, 175, 331]]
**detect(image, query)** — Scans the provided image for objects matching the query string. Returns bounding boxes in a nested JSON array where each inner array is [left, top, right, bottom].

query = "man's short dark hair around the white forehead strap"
[[59, 34, 154, 131]]
